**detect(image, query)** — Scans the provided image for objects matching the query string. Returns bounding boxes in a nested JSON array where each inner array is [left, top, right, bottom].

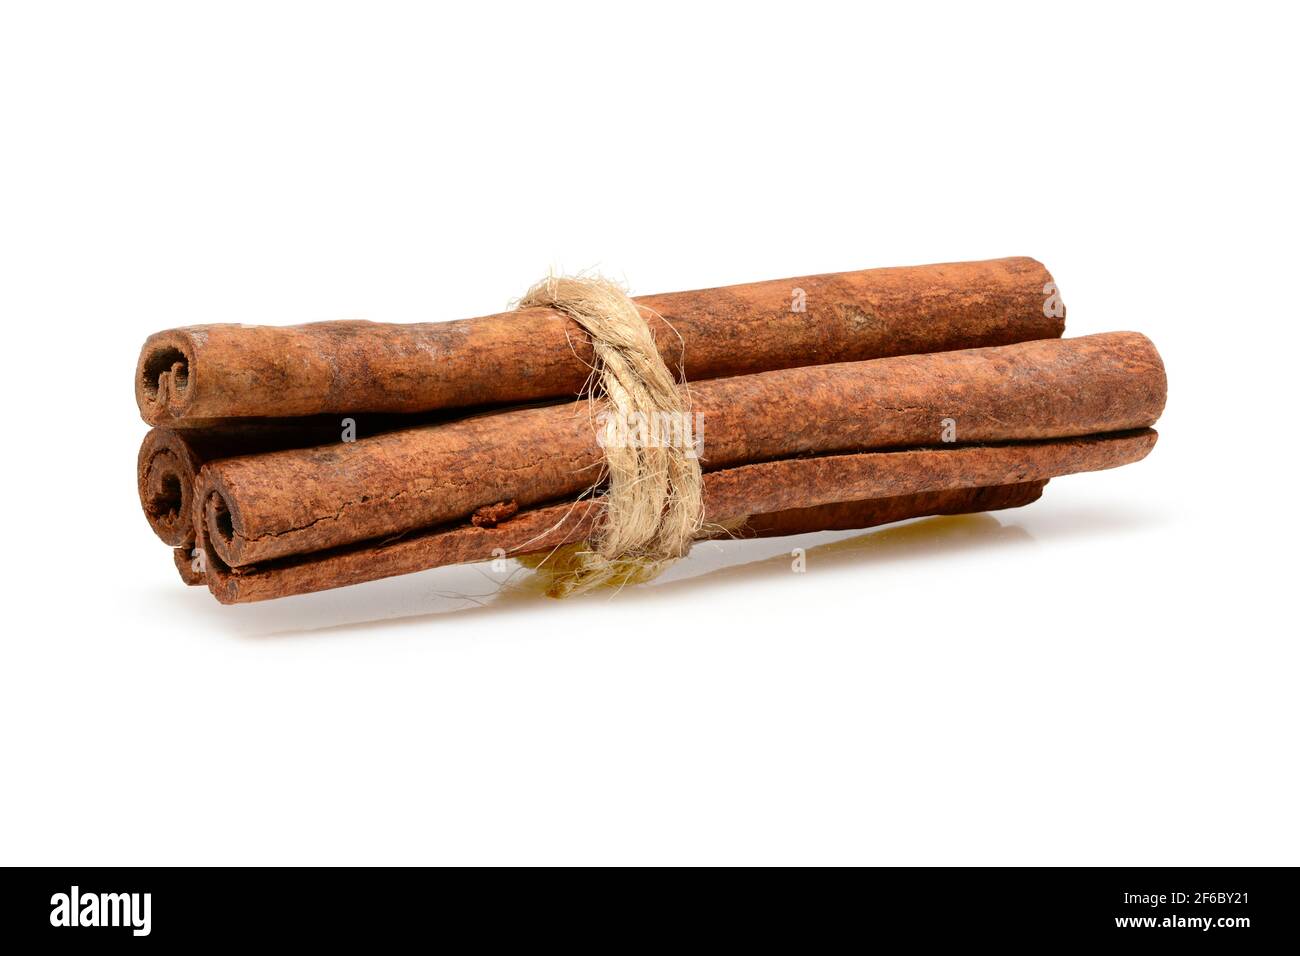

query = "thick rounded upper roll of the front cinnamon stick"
[[195, 333, 1165, 567]]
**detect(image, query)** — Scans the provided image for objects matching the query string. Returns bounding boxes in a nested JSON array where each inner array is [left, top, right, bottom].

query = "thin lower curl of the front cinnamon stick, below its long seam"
[[199, 429, 1156, 604]]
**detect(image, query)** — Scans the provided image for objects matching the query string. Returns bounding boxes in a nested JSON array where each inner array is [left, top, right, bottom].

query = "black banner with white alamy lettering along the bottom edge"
[[0, 868, 1300, 949]]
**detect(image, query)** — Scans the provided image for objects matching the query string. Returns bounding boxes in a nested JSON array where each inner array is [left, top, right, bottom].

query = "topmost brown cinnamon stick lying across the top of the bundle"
[[135, 258, 1065, 425]]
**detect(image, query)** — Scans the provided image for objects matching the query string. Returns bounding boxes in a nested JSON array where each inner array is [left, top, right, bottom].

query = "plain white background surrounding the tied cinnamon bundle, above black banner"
[[0, 3, 1300, 865]]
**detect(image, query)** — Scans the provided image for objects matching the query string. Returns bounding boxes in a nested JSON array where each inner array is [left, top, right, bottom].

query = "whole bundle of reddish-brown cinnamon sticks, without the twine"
[[135, 258, 1166, 604]]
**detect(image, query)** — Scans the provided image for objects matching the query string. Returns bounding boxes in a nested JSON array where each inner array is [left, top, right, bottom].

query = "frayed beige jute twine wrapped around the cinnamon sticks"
[[519, 276, 703, 597]]
